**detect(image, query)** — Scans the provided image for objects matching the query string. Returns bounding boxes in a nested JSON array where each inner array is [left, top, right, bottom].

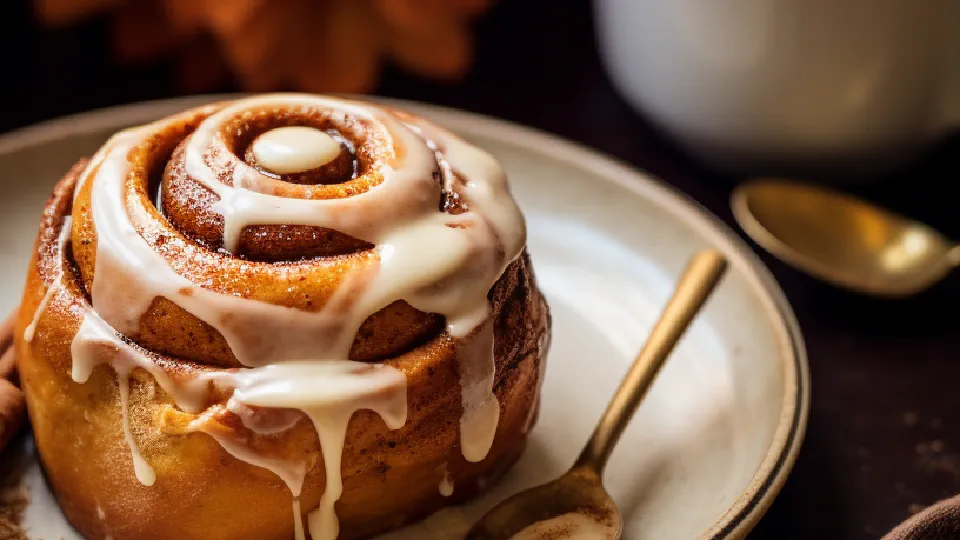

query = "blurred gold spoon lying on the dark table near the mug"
[[730, 179, 960, 297]]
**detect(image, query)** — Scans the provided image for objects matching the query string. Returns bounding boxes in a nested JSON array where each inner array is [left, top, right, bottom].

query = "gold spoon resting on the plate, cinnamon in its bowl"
[[464, 250, 727, 540]]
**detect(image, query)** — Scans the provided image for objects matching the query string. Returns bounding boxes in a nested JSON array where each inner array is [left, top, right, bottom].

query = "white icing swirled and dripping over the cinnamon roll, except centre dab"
[[56, 94, 526, 540]]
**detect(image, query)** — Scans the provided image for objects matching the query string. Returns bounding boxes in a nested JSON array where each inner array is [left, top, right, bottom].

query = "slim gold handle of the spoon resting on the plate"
[[574, 250, 727, 476]]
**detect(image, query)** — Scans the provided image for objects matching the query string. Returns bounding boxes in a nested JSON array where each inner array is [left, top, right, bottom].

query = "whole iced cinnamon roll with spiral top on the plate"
[[15, 94, 550, 540]]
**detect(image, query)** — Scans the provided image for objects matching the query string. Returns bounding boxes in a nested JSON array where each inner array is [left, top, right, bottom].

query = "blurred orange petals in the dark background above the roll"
[[34, 0, 492, 93]]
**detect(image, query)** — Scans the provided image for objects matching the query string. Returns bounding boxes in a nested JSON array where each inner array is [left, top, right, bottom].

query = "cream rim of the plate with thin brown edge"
[[0, 94, 810, 540]]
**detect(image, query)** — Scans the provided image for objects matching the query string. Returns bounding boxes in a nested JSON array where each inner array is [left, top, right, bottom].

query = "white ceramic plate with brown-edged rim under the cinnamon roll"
[[0, 97, 809, 540]]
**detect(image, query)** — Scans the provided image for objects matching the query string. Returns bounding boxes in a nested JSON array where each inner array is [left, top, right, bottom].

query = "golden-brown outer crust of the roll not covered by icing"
[[16, 98, 549, 540]]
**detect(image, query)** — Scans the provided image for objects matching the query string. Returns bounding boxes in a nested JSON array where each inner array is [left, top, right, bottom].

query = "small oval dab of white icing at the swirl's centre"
[[251, 126, 341, 174]]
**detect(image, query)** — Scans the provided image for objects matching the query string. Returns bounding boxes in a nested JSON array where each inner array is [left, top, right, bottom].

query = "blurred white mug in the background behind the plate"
[[595, 0, 960, 174]]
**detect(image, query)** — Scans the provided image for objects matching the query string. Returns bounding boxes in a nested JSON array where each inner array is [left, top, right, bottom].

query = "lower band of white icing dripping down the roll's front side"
[[72, 312, 407, 540]]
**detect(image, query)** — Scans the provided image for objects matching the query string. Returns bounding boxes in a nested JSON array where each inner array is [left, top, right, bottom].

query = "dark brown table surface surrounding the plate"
[[0, 0, 960, 540]]
